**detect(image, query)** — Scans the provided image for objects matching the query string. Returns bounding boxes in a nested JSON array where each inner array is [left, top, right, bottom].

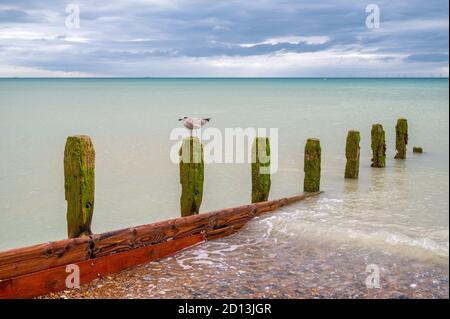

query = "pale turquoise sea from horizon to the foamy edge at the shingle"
[[0, 79, 449, 268]]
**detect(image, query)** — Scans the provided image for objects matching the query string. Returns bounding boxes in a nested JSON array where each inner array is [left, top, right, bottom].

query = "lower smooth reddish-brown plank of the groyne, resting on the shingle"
[[0, 234, 205, 299]]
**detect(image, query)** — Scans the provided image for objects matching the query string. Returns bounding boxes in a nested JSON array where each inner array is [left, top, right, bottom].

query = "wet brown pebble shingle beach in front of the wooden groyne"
[[40, 213, 449, 299]]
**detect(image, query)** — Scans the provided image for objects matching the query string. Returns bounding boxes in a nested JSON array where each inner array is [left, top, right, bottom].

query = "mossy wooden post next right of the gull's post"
[[252, 137, 270, 203]]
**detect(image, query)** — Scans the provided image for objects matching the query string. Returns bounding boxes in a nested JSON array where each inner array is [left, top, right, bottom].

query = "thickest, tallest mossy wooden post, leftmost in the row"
[[64, 135, 95, 238]]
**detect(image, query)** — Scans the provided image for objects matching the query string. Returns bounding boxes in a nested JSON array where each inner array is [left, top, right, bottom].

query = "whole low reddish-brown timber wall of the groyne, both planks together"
[[0, 192, 318, 298]]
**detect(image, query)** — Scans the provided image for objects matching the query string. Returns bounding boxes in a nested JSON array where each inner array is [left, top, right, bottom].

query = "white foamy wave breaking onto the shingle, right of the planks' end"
[[249, 210, 449, 263]]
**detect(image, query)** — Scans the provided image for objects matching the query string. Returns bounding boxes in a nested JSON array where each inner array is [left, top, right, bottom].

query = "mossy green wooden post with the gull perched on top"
[[179, 136, 205, 216]]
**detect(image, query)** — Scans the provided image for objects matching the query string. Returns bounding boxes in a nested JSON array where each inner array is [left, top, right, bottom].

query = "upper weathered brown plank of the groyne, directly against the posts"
[[0, 193, 318, 279]]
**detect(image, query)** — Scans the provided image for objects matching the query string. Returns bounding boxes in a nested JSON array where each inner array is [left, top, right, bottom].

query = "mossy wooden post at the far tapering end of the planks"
[[303, 138, 322, 193]]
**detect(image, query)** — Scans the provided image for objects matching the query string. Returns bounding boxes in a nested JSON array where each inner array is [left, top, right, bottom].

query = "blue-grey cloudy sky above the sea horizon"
[[0, 0, 449, 77]]
